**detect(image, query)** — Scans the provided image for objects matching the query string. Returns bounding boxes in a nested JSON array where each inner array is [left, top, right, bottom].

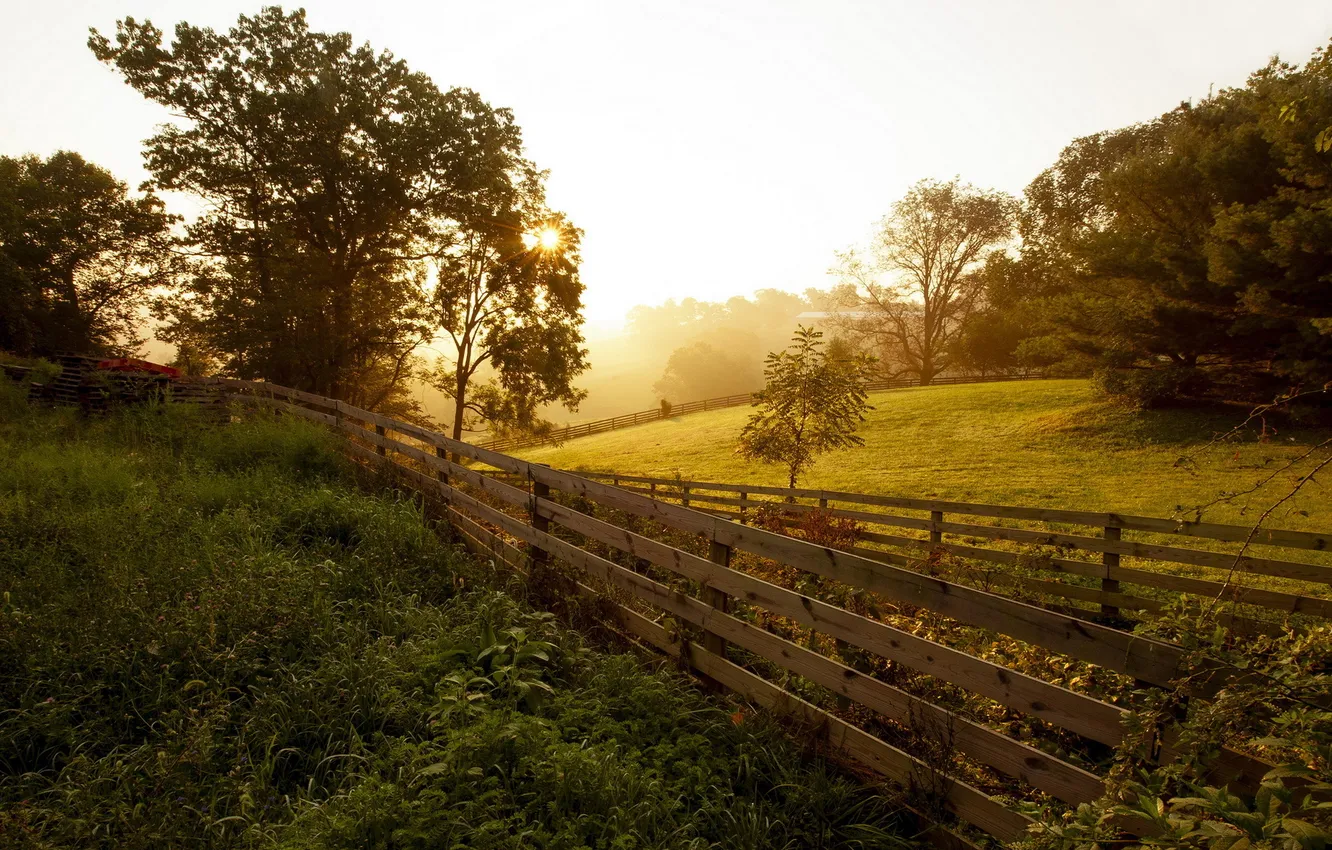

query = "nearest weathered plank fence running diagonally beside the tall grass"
[[220, 381, 1321, 847]]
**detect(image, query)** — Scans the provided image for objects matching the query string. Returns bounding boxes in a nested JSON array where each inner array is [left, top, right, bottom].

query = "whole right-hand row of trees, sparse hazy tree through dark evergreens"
[[838, 41, 1332, 404]]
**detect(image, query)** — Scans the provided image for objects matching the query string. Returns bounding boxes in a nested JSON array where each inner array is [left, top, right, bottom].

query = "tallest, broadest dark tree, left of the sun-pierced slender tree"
[[89, 8, 523, 408]]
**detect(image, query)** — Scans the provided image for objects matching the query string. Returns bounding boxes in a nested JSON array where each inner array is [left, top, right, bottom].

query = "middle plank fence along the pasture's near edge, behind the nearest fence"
[[567, 472, 1332, 630]]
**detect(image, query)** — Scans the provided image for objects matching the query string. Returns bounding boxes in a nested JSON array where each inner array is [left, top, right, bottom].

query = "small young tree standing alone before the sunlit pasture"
[[737, 326, 874, 488]]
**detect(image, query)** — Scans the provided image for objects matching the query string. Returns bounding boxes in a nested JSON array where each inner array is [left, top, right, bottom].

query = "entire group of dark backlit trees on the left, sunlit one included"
[[0, 8, 586, 436]]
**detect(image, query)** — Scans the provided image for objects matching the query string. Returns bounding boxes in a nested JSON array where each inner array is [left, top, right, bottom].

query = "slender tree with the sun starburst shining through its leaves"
[[432, 191, 587, 440]]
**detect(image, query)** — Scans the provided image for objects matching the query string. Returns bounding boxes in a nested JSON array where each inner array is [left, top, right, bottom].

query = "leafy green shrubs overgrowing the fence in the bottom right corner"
[[1028, 604, 1332, 850]]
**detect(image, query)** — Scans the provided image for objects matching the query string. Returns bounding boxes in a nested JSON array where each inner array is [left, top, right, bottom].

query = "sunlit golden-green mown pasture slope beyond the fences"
[[518, 380, 1332, 529]]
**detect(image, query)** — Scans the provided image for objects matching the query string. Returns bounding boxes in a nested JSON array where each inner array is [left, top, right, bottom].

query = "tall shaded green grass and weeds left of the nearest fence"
[[0, 386, 898, 850]]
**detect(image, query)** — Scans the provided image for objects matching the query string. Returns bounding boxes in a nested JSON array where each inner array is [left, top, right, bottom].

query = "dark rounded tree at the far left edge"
[[0, 151, 180, 354]]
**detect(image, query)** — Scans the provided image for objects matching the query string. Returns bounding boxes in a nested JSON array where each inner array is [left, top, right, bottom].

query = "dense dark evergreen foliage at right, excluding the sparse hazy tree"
[[987, 39, 1332, 398]]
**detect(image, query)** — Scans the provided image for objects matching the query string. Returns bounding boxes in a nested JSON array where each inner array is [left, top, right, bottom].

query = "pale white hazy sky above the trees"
[[0, 0, 1332, 330]]
